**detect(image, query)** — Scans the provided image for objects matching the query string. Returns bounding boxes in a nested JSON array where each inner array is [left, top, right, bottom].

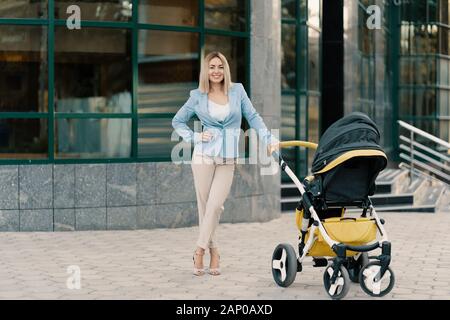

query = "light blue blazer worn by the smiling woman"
[[172, 83, 278, 158]]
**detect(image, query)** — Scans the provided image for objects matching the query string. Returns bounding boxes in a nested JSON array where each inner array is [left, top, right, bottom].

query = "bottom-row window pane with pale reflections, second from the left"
[[55, 119, 131, 159]]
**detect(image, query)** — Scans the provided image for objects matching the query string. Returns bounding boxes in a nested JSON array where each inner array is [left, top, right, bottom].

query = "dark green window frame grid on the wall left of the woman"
[[0, 0, 251, 165]]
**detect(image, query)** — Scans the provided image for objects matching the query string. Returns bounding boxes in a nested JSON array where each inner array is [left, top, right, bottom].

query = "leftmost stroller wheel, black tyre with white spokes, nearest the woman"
[[272, 243, 297, 287]]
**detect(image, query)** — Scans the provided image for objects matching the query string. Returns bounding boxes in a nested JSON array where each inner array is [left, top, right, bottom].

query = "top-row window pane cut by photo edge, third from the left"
[[139, 0, 199, 27]]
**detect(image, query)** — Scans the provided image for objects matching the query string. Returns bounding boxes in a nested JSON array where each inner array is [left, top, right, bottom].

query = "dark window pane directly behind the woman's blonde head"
[[205, 34, 248, 85]]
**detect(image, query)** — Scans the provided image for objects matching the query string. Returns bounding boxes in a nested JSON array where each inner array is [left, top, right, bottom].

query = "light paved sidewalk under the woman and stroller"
[[0, 212, 450, 300]]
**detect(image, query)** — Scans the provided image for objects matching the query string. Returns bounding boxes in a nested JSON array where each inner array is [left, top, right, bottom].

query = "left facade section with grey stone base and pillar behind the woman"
[[0, 0, 281, 231]]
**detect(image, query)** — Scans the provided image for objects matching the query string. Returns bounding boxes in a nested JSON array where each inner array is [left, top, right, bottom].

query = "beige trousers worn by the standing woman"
[[191, 154, 235, 249]]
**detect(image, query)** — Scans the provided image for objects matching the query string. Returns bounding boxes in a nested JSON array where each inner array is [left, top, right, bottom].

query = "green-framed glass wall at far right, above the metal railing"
[[394, 0, 450, 139]]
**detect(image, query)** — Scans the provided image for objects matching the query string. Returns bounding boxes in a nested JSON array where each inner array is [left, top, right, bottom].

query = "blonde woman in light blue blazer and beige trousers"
[[172, 52, 278, 276]]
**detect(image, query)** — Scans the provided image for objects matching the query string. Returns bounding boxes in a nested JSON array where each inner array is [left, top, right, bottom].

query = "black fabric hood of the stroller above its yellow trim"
[[311, 112, 383, 173]]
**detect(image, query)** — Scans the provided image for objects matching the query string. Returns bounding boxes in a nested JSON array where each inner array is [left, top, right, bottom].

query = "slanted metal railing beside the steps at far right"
[[398, 120, 450, 184]]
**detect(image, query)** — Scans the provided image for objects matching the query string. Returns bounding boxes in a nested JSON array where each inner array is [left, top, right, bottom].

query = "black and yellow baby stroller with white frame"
[[271, 112, 395, 299]]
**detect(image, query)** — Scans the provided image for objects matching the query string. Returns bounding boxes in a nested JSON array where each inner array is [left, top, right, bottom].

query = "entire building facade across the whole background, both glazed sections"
[[0, 0, 450, 231]]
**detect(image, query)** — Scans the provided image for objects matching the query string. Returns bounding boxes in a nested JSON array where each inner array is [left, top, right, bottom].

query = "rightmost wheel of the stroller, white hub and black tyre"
[[359, 261, 395, 297]]
